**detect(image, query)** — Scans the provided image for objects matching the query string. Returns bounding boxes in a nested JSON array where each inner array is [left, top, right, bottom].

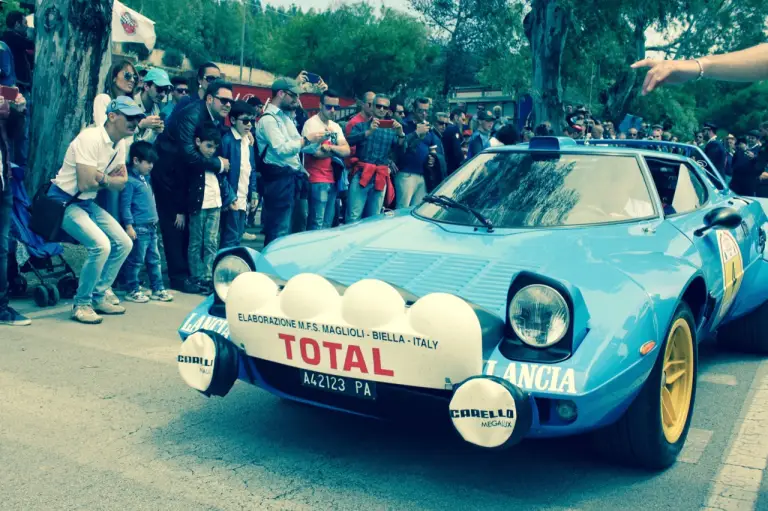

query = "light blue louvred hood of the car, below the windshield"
[[257, 211, 691, 317]]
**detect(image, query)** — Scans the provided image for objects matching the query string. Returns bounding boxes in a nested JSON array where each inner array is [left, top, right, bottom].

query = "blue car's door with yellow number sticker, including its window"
[[646, 157, 758, 322]]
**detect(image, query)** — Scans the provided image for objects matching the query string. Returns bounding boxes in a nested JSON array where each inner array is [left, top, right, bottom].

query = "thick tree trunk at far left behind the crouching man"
[[26, 0, 113, 194]]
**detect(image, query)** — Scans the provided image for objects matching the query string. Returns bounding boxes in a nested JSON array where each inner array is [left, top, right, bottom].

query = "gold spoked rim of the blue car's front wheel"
[[661, 318, 695, 444]]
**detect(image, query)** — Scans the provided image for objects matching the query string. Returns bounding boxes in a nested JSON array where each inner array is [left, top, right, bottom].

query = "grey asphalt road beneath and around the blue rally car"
[[0, 294, 768, 511]]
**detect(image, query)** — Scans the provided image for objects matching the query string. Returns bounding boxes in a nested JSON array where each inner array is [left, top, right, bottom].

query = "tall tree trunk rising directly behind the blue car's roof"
[[530, 0, 570, 135]]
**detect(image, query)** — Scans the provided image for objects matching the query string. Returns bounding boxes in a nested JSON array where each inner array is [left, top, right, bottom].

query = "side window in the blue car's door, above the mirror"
[[646, 158, 708, 216]]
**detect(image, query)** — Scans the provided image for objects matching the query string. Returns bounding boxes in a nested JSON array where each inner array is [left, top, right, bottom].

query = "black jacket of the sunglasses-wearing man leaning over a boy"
[[152, 100, 229, 214]]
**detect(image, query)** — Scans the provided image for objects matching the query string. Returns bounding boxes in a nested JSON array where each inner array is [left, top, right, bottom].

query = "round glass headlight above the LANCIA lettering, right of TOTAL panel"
[[509, 284, 571, 348]]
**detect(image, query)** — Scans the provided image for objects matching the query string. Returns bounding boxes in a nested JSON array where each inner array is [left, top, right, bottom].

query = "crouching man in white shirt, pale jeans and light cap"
[[48, 96, 144, 324]]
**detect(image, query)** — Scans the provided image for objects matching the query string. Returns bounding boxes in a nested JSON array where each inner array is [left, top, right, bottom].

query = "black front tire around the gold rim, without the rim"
[[593, 302, 699, 471]]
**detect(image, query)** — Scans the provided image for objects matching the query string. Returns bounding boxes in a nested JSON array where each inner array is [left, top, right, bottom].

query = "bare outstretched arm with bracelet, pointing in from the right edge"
[[632, 43, 768, 95]]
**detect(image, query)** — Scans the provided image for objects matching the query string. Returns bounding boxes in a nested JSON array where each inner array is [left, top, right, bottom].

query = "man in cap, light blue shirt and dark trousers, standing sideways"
[[256, 78, 329, 246]]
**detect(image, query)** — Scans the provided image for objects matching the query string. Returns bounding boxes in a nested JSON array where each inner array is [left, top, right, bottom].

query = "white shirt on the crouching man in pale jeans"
[[52, 126, 126, 200]]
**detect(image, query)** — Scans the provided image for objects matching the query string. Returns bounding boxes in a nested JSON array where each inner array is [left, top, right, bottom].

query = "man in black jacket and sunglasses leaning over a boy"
[[152, 80, 233, 292]]
